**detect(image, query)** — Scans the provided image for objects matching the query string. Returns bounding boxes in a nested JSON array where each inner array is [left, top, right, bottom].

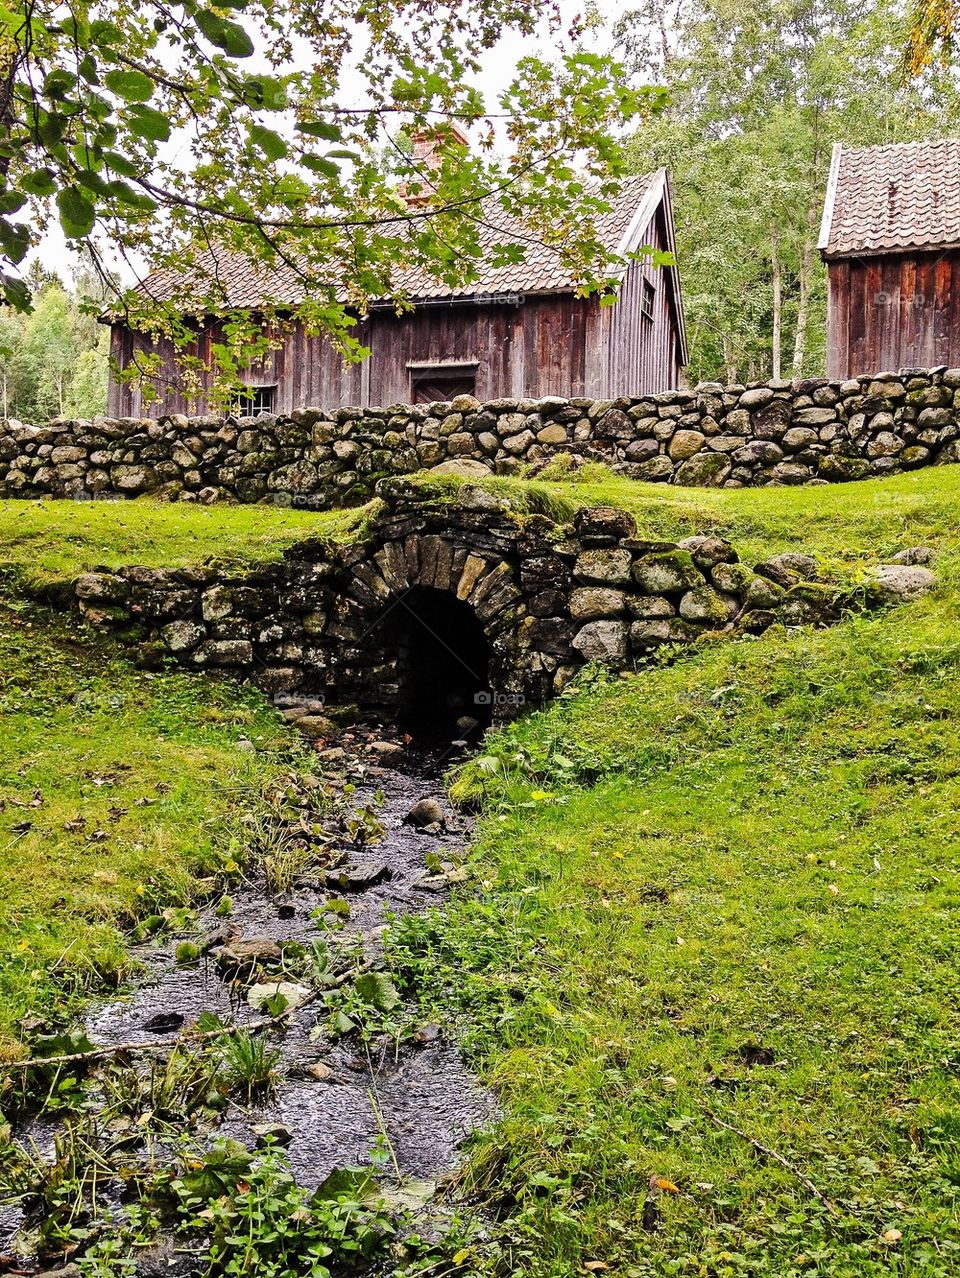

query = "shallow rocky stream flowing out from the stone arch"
[[0, 731, 495, 1272]]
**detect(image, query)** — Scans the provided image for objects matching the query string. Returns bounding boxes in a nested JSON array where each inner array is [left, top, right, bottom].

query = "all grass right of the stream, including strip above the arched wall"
[[394, 468, 960, 1278]]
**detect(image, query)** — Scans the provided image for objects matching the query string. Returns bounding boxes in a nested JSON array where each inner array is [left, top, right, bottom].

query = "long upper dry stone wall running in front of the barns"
[[0, 368, 960, 509]]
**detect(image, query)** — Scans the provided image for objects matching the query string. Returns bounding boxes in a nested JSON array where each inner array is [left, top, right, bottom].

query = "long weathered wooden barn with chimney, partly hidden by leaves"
[[109, 170, 686, 417]]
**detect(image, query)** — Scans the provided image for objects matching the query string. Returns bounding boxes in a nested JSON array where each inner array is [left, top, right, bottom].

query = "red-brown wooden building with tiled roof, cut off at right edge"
[[819, 138, 960, 378]]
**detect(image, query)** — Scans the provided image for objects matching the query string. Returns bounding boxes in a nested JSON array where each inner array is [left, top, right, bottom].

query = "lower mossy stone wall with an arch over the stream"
[[63, 479, 933, 717]]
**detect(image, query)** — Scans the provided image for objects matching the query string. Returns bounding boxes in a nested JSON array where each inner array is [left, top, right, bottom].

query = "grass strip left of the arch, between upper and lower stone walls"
[[0, 498, 362, 585]]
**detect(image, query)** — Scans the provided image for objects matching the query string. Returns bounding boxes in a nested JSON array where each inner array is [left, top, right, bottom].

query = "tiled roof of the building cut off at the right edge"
[[819, 138, 960, 257]]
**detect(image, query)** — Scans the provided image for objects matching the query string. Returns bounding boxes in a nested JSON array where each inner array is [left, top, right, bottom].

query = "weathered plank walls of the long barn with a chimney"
[[110, 207, 680, 417]]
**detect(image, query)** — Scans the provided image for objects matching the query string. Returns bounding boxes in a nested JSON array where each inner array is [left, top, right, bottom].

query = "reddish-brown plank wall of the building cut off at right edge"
[[827, 249, 960, 378]]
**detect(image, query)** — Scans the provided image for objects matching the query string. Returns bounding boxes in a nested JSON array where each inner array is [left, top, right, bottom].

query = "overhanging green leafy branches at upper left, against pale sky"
[[0, 0, 656, 398]]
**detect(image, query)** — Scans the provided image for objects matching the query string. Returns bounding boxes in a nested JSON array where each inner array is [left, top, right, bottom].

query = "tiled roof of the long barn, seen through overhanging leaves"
[[133, 170, 662, 309]]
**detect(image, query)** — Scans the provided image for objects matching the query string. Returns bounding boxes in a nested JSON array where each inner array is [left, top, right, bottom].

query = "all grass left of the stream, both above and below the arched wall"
[[0, 488, 358, 1059]]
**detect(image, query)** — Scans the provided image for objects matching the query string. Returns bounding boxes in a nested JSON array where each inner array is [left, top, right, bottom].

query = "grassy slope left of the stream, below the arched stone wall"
[[0, 602, 291, 1059]]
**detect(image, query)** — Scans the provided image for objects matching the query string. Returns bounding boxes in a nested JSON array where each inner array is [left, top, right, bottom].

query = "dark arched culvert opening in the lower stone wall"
[[383, 587, 492, 744]]
